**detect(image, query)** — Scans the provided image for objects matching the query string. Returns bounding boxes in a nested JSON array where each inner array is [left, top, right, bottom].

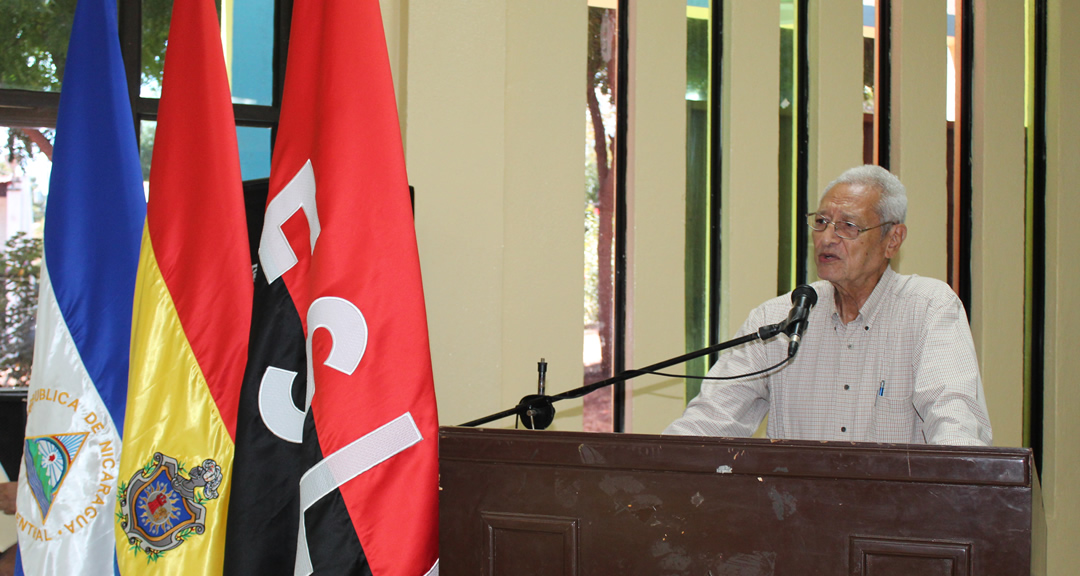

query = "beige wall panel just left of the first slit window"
[[501, 0, 588, 428]]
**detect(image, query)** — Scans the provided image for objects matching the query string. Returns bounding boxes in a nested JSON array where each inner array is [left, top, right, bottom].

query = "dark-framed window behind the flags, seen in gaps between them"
[[0, 0, 289, 386]]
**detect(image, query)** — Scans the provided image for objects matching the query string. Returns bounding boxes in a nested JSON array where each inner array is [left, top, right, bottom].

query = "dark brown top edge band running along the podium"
[[440, 427, 1035, 487]]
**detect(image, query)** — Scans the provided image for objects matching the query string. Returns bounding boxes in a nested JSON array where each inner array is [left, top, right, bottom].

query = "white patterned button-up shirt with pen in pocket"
[[664, 268, 991, 445]]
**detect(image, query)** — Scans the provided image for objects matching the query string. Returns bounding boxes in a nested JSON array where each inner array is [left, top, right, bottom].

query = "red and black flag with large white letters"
[[226, 0, 438, 576]]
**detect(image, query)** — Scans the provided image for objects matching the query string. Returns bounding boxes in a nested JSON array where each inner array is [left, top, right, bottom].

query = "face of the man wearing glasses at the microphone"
[[813, 184, 906, 296]]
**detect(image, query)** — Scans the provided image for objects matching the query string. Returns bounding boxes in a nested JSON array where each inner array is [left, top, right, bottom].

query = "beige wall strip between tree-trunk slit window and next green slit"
[[626, 2, 686, 433]]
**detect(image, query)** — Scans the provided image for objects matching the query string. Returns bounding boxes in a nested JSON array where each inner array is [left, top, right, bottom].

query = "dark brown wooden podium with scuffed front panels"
[[440, 427, 1043, 576]]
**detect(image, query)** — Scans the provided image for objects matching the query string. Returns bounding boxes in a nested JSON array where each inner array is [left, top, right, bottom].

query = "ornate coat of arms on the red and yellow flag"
[[117, 452, 221, 560]]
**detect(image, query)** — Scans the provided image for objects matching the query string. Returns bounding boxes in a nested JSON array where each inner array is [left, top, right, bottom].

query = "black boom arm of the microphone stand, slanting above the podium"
[[460, 322, 785, 430]]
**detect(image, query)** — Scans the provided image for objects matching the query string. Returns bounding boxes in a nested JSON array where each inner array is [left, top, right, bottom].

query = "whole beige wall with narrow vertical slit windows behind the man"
[[393, 0, 1080, 574]]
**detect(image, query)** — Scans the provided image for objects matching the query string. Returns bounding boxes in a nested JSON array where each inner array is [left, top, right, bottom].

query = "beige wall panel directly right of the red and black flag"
[[403, 0, 507, 424]]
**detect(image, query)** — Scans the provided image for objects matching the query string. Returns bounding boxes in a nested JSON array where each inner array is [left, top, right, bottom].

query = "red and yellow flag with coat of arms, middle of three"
[[116, 0, 252, 576]]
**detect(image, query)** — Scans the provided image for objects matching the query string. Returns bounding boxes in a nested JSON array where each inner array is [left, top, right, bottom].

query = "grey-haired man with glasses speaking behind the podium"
[[664, 165, 991, 445]]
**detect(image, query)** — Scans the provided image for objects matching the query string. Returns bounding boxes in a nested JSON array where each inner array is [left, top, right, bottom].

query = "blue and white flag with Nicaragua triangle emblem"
[[16, 0, 146, 575]]
